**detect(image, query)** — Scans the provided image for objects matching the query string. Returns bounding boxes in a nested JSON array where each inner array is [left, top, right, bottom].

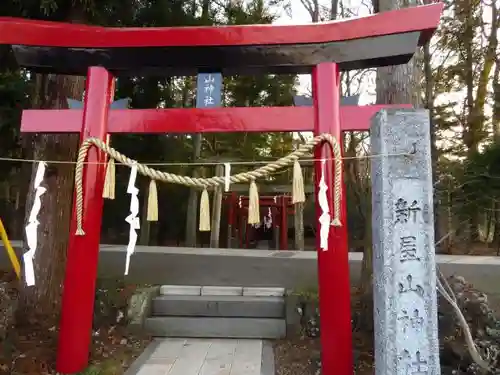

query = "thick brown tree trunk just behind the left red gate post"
[[20, 75, 85, 316]]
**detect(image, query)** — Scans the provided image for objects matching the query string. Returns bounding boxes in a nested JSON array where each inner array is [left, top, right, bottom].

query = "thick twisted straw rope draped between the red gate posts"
[[75, 134, 342, 236]]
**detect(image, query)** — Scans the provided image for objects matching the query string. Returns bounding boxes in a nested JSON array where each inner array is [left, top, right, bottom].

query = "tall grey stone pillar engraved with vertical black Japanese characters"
[[371, 109, 440, 375]]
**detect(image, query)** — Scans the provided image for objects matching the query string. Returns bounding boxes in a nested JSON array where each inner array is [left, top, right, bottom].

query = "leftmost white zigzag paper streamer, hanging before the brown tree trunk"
[[23, 161, 47, 286]]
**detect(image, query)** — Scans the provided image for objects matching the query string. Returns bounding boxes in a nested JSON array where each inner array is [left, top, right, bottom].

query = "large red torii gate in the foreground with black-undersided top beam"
[[0, 4, 443, 375]]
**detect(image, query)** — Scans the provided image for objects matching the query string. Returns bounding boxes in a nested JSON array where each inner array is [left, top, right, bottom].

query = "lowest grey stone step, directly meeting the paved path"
[[145, 316, 286, 339]]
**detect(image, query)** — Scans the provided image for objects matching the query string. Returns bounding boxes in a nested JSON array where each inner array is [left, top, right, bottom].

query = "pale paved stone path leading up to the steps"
[[125, 338, 274, 375]]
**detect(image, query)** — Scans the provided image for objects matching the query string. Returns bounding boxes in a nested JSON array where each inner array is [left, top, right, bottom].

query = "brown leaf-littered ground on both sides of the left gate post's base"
[[0, 274, 151, 375]]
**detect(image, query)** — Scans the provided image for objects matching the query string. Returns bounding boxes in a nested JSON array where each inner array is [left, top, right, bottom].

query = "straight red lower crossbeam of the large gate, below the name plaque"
[[21, 105, 402, 134]]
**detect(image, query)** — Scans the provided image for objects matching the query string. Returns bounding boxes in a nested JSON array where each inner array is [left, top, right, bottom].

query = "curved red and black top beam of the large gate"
[[0, 3, 443, 76]]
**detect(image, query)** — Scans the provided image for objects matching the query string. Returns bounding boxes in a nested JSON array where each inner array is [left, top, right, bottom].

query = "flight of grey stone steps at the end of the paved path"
[[145, 285, 286, 339]]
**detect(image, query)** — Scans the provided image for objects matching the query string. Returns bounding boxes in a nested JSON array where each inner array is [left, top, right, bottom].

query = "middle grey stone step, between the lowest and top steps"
[[151, 295, 285, 318]]
